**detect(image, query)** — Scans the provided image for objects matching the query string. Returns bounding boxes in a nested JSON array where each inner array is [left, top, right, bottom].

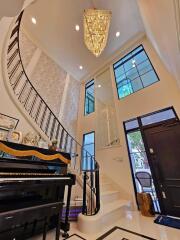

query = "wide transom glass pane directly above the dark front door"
[[141, 109, 176, 126]]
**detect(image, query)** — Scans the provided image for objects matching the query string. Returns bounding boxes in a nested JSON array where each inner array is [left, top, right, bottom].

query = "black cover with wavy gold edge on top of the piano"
[[0, 141, 71, 164]]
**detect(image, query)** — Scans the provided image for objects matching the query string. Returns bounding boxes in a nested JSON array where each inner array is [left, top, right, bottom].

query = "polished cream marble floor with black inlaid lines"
[[31, 211, 180, 240]]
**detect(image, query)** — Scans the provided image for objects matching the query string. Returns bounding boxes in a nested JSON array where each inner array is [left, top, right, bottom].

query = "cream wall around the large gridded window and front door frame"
[[78, 38, 180, 208]]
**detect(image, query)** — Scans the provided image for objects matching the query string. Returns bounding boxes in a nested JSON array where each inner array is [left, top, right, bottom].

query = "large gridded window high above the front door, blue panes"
[[113, 45, 159, 98]]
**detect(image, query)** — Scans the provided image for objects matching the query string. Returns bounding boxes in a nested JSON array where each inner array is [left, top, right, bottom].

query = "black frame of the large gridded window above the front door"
[[113, 44, 160, 100]]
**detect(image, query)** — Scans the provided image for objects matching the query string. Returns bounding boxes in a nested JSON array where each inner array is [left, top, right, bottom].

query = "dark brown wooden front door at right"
[[144, 122, 180, 217]]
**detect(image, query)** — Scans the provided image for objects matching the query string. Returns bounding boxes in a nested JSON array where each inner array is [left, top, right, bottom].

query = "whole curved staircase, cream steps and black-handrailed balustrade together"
[[4, 9, 130, 234]]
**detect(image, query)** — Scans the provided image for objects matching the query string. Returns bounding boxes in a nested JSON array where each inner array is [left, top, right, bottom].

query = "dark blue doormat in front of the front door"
[[154, 215, 180, 229]]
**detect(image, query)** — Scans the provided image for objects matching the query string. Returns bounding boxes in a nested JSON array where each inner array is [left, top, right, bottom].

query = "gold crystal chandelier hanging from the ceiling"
[[83, 9, 112, 57]]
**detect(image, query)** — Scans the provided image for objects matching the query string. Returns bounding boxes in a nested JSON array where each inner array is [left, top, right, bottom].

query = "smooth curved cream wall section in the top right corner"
[[138, 0, 180, 86]]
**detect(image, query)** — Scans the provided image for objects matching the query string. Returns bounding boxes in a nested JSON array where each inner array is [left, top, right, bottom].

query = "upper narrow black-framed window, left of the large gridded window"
[[85, 80, 94, 115]]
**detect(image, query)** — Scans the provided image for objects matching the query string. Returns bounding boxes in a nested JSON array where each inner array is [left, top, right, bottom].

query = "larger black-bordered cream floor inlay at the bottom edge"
[[97, 227, 156, 240]]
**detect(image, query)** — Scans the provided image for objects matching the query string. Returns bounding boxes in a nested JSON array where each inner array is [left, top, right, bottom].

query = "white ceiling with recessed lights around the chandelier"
[[23, 0, 144, 79]]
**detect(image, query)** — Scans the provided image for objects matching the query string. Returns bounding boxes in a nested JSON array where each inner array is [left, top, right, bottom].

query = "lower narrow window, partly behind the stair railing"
[[82, 132, 95, 170]]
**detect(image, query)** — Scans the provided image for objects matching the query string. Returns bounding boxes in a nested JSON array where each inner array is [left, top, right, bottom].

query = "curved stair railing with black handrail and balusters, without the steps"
[[3, 12, 100, 216]]
